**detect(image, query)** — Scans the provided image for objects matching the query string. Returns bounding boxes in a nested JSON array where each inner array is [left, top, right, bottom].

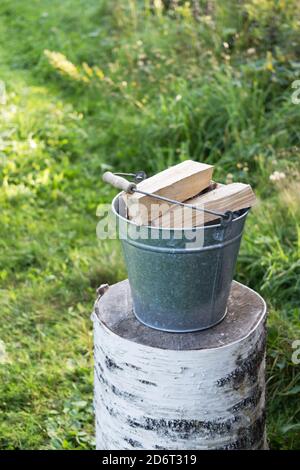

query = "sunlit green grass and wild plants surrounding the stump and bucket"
[[0, 0, 300, 449]]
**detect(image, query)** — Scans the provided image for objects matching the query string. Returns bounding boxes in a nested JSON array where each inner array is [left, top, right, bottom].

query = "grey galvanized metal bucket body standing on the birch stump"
[[112, 195, 249, 333]]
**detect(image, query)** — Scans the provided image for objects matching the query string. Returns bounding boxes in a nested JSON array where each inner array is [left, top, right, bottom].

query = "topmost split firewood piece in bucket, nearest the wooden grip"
[[124, 160, 213, 225]]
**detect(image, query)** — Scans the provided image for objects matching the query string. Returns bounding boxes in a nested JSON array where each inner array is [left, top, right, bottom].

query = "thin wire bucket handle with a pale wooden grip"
[[102, 171, 234, 227]]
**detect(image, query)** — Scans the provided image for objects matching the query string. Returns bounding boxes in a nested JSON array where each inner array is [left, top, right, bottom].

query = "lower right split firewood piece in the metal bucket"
[[152, 183, 256, 228]]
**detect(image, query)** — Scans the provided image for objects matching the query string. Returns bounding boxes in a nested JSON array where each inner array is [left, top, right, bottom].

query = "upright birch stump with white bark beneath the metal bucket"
[[93, 281, 266, 450]]
